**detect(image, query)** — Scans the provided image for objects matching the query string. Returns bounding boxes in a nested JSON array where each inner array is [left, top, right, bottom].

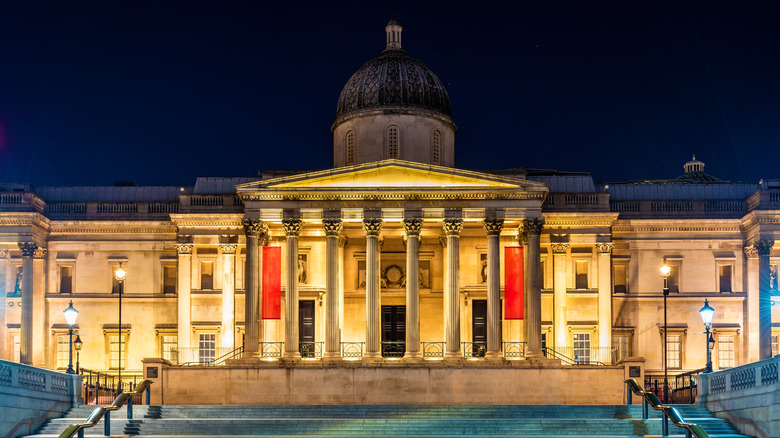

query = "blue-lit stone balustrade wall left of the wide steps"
[[0, 360, 81, 438]]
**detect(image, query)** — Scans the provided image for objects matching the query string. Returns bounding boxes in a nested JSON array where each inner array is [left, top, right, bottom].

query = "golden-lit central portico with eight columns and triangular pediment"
[[237, 160, 548, 361]]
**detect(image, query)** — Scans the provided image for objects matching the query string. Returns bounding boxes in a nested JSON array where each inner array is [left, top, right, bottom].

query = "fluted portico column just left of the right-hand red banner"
[[484, 218, 504, 359]]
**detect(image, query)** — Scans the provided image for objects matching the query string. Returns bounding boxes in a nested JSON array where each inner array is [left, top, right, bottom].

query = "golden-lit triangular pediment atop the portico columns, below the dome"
[[238, 160, 544, 192]]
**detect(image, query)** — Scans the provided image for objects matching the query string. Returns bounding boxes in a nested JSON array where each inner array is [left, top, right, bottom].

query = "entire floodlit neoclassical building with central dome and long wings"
[[0, 19, 780, 384]]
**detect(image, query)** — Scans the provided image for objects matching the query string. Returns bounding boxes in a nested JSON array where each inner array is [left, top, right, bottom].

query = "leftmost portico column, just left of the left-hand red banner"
[[241, 219, 267, 359]]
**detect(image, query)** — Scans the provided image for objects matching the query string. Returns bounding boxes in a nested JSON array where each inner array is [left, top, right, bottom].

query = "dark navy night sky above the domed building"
[[0, 0, 780, 186]]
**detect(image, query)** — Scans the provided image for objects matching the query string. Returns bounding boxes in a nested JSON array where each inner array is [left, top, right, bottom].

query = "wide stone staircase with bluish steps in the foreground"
[[31, 405, 745, 438]]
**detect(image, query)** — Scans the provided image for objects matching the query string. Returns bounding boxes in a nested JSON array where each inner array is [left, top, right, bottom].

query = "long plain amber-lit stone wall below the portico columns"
[[144, 359, 637, 405]]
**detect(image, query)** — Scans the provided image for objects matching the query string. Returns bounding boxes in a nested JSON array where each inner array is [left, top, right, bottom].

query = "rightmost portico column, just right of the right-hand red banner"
[[524, 218, 544, 358]]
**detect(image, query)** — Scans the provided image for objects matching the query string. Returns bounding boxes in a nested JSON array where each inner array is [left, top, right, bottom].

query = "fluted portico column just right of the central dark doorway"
[[404, 218, 423, 359]]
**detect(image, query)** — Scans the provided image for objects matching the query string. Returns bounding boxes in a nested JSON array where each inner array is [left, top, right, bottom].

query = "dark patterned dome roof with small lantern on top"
[[334, 17, 454, 127]]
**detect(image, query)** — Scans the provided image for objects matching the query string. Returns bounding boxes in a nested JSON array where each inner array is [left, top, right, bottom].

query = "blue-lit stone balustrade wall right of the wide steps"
[[697, 356, 780, 438]]
